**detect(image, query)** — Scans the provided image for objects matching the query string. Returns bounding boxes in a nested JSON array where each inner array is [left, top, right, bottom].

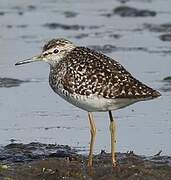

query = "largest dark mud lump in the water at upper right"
[[114, 6, 156, 17]]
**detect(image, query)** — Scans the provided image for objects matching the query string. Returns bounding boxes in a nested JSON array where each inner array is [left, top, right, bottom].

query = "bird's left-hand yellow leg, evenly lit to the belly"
[[87, 112, 96, 167]]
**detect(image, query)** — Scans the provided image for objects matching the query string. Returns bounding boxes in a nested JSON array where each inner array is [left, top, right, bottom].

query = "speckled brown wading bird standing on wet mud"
[[15, 38, 161, 167]]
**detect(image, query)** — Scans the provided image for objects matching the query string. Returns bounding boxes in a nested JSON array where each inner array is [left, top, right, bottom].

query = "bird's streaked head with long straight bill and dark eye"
[[15, 39, 75, 66]]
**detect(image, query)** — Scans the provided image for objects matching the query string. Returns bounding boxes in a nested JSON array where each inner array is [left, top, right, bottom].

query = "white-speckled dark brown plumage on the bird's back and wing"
[[49, 47, 159, 98]]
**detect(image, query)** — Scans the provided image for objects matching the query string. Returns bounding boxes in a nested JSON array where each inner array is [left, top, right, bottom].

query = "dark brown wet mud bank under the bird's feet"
[[0, 143, 171, 180]]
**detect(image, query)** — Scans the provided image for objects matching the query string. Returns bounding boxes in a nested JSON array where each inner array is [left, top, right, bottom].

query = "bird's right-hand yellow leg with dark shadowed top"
[[109, 111, 116, 167]]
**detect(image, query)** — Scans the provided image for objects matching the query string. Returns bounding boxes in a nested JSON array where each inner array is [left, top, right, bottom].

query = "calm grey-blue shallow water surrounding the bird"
[[0, 0, 171, 155]]
